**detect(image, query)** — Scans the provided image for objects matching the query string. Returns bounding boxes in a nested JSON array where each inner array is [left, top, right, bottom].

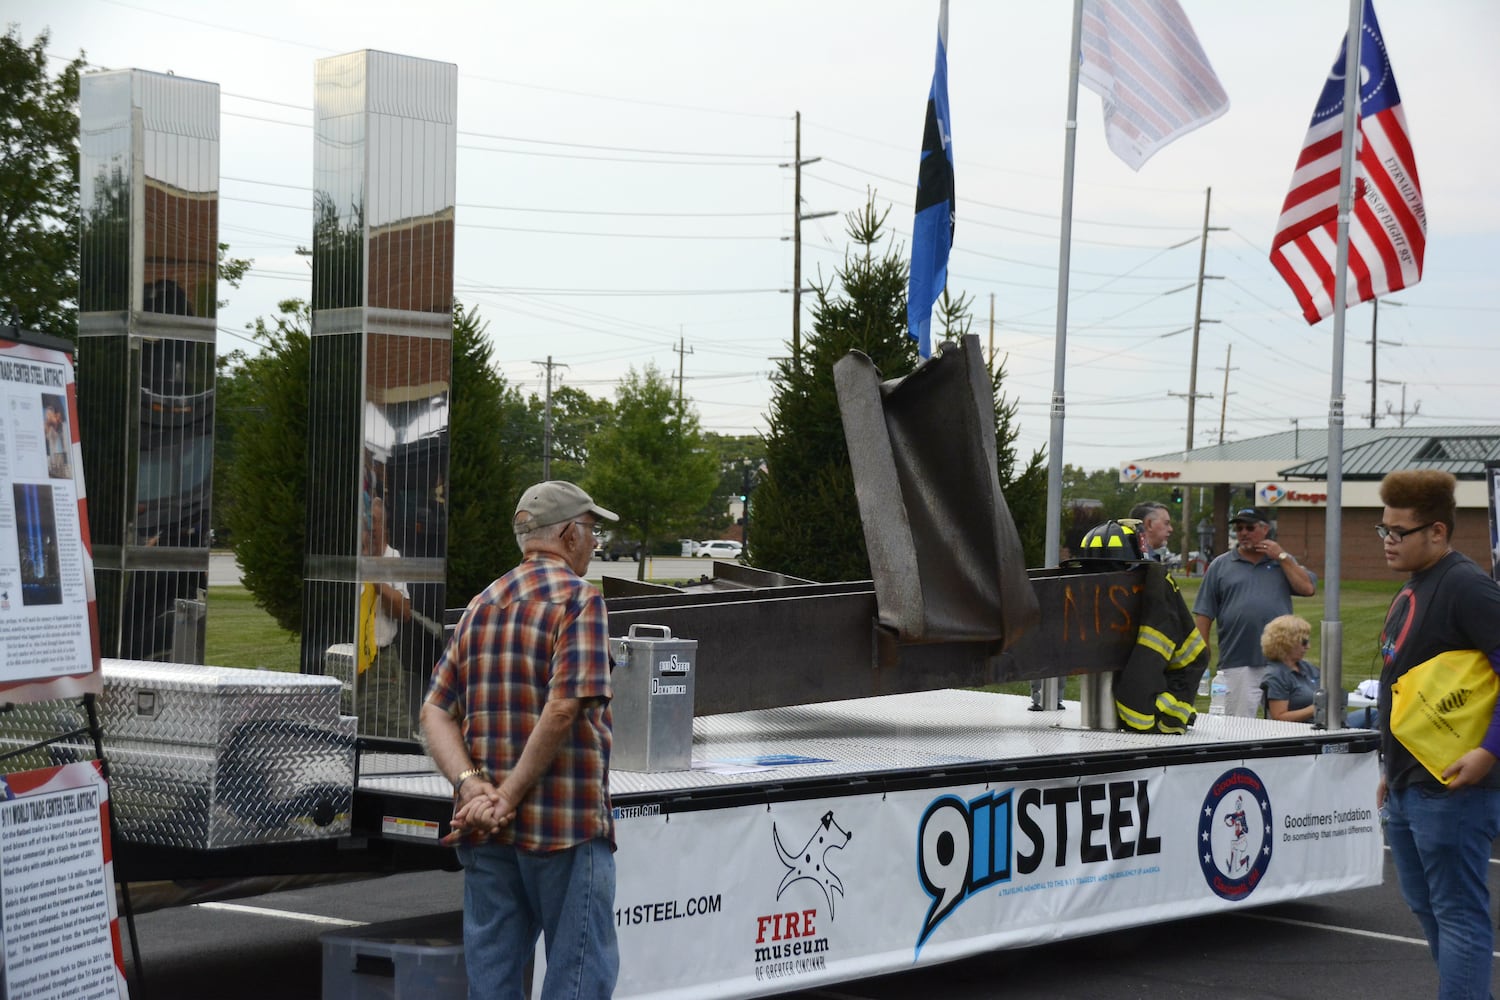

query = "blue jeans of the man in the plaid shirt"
[[458, 838, 620, 1000]]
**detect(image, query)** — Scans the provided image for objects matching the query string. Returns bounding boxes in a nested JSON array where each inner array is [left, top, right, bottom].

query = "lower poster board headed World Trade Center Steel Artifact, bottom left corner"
[[0, 762, 129, 1000]]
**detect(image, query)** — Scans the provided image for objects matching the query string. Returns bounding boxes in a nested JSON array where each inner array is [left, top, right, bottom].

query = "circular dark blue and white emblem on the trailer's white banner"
[[1199, 768, 1272, 901]]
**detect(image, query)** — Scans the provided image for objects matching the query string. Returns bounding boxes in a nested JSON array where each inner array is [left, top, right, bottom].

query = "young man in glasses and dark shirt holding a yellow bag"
[[1376, 469, 1500, 1000]]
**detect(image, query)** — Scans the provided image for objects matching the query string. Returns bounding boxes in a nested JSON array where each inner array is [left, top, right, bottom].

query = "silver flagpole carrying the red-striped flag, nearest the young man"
[[1313, 0, 1365, 729]]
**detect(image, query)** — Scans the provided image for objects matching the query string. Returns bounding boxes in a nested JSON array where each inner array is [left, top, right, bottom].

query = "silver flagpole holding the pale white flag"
[[1032, 0, 1098, 719]]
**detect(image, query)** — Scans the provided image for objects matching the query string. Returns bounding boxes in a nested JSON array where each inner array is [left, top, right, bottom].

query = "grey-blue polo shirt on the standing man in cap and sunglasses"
[[1193, 547, 1317, 667]]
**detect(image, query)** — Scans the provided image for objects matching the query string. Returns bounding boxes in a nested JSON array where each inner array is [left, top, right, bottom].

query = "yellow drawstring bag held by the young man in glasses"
[[1391, 649, 1500, 784]]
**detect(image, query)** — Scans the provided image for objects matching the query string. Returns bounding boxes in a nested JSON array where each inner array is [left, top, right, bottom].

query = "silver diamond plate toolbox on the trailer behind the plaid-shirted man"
[[3, 660, 356, 849]]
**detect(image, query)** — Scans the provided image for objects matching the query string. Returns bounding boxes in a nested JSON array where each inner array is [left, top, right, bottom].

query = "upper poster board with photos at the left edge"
[[0, 339, 102, 702]]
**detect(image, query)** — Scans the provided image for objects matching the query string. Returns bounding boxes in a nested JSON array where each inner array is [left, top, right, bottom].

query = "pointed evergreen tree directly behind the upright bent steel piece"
[[749, 199, 1047, 582]]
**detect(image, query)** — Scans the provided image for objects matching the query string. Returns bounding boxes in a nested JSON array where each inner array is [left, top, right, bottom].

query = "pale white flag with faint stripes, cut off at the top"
[[1079, 0, 1229, 169]]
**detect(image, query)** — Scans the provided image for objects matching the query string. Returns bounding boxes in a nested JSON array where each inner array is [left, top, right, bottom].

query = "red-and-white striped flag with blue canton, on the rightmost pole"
[[1271, 0, 1427, 322]]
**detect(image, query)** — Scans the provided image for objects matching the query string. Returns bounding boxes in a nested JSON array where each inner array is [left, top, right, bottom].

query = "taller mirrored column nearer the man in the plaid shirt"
[[310, 51, 458, 739]]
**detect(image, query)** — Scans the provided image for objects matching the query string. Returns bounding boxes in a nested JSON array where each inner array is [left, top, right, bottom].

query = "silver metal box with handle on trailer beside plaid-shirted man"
[[609, 624, 698, 771]]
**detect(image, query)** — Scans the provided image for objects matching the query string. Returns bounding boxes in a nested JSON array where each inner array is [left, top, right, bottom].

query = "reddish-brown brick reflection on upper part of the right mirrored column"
[[369, 208, 453, 313]]
